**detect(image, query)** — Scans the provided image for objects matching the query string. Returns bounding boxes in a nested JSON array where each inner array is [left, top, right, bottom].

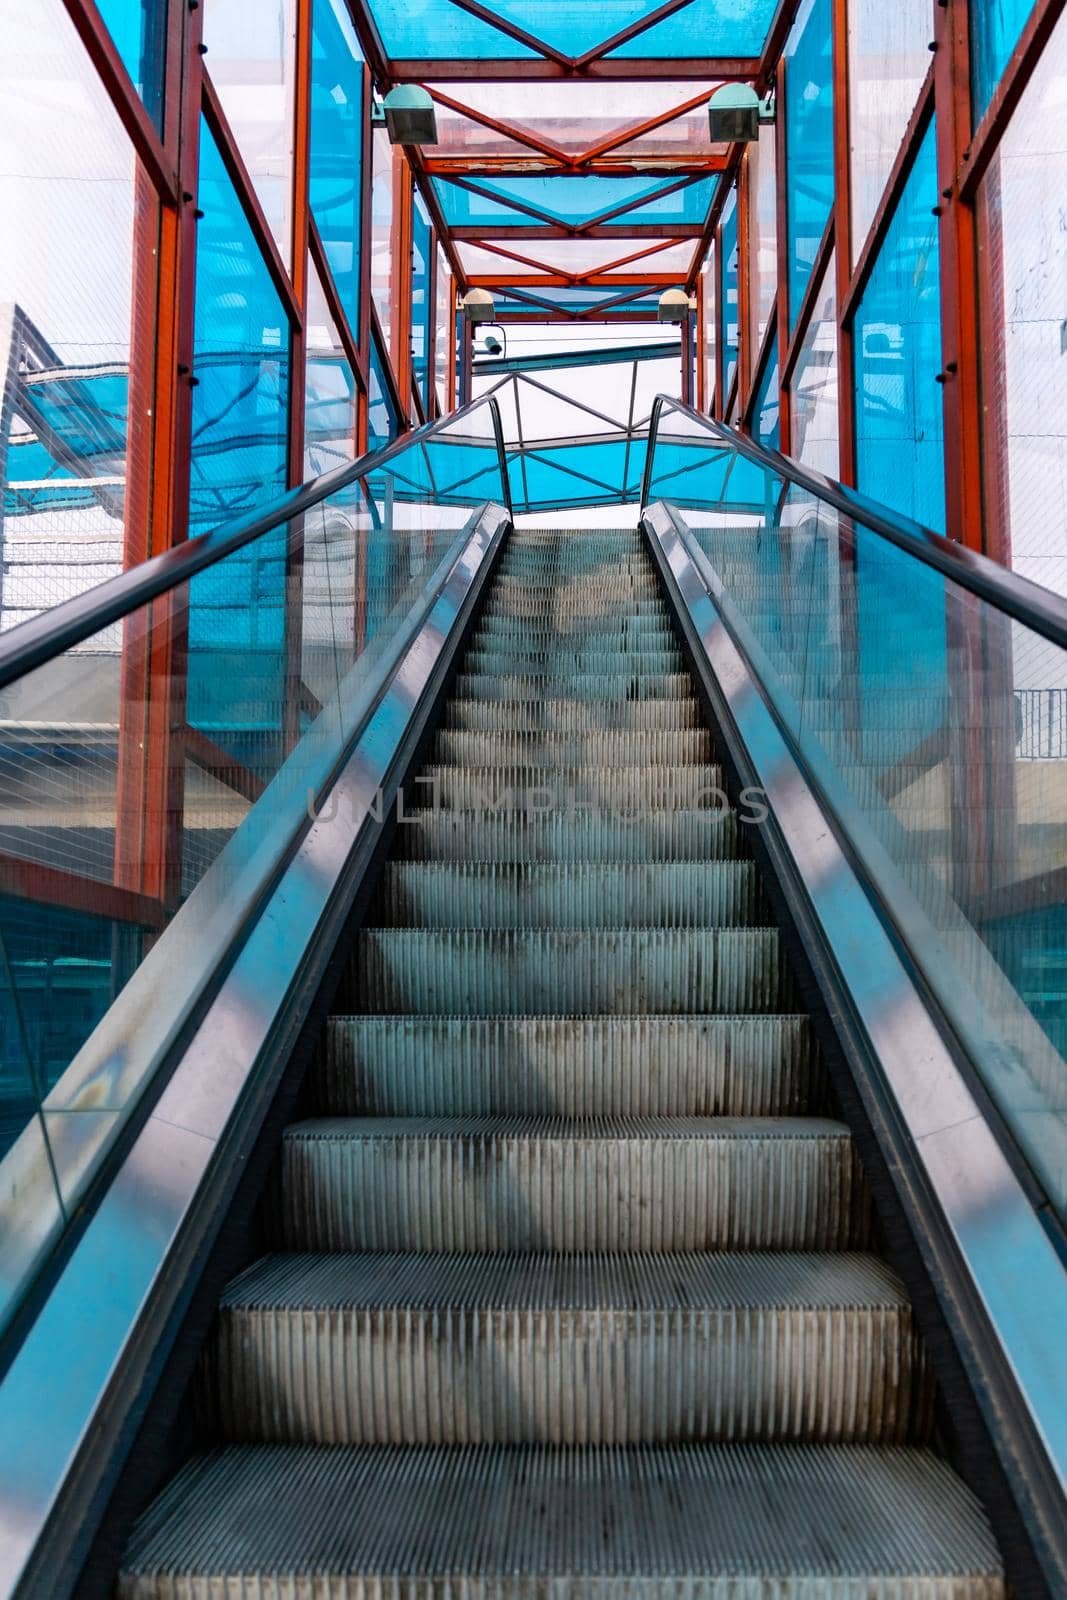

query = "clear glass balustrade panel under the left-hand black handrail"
[[0, 390, 504, 1322]]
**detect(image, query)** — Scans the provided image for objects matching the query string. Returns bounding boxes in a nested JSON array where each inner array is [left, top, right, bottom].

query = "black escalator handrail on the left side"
[[0, 395, 512, 690]]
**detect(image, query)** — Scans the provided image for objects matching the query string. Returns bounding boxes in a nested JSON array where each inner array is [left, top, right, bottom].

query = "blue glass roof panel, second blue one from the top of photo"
[[434, 178, 713, 232]]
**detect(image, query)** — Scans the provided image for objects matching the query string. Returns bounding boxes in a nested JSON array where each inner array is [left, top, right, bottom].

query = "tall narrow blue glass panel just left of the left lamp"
[[310, 0, 363, 330]]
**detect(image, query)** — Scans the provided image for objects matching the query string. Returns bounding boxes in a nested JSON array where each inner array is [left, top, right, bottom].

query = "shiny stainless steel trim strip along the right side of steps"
[[643, 504, 1067, 1592]]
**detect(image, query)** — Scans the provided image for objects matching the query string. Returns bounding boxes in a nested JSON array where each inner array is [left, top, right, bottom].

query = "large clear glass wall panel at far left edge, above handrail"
[[0, 0, 158, 629]]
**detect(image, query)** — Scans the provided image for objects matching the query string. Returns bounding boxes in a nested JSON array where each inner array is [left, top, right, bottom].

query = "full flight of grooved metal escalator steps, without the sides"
[[118, 531, 1003, 1600]]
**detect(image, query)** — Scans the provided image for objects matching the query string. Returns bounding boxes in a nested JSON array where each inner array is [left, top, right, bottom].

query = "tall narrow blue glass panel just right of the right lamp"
[[785, 0, 833, 328]]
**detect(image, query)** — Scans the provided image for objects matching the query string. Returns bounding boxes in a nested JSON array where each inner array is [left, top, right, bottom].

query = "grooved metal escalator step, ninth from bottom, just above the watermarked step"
[[432, 728, 715, 766]]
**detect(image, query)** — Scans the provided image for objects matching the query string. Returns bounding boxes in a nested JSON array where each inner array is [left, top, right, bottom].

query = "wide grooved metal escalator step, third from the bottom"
[[272, 1117, 869, 1254]]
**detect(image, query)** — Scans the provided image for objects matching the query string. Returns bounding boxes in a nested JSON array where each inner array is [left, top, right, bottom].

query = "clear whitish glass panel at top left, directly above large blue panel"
[[203, 0, 296, 266]]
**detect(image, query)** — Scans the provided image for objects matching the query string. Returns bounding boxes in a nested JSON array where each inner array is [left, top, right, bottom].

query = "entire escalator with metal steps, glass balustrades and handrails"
[[0, 398, 1067, 1600]]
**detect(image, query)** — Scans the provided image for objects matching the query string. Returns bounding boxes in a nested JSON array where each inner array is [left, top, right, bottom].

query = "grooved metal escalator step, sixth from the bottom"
[[366, 859, 771, 928]]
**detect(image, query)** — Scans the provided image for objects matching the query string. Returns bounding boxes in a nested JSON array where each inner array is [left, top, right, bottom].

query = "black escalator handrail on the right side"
[[641, 395, 1067, 650]]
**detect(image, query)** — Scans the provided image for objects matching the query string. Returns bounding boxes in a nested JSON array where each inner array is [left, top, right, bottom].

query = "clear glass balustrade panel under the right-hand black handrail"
[[649, 396, 1067, 1218]]
